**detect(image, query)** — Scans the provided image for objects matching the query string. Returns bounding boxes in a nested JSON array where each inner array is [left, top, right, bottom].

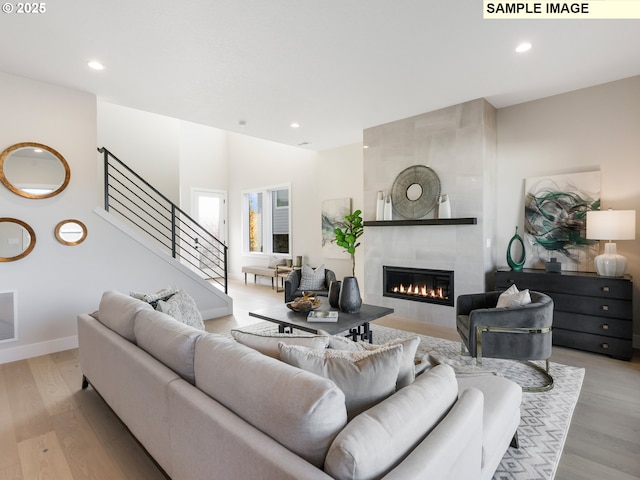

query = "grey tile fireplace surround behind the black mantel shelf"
[[363, 99, 496, 327]]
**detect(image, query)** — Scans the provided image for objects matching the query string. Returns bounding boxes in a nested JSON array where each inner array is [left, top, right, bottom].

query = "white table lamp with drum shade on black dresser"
[[587, 209, 636, 277]]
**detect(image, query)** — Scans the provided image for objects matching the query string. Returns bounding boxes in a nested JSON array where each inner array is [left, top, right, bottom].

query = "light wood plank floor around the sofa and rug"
[[0, 280, 640, 480]]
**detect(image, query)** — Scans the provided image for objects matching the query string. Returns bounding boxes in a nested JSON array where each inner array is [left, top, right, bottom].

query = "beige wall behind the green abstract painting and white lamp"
[[497, 76, 640, 347]]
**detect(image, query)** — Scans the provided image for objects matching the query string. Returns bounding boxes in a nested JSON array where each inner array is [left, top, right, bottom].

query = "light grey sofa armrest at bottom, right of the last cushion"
[[383, 388, 484, 480]]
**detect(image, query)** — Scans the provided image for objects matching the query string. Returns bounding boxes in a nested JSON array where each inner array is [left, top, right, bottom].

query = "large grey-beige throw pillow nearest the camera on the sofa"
[[278, 343, 402, 419]]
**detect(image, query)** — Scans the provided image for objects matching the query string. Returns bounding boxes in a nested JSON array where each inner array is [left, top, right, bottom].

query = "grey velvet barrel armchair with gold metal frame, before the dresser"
[[456, 291, 553, 392]]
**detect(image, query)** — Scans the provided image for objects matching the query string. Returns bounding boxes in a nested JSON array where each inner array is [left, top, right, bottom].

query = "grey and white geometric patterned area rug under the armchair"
[[235, 322, 584, 480]]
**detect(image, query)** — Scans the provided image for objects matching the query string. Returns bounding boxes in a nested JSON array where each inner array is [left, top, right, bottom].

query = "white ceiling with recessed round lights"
[[0, 0, 640, 150]]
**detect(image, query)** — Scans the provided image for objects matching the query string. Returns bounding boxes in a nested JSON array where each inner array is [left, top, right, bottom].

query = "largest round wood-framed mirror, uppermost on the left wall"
[[0, 142, 71, 198]]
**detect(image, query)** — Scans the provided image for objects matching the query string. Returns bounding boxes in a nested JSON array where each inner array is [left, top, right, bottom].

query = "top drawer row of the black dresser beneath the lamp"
[[495, 270, 633, 300]]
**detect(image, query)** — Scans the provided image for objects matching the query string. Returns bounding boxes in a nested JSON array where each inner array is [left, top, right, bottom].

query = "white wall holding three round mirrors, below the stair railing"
[[0, 73, 230, 363]]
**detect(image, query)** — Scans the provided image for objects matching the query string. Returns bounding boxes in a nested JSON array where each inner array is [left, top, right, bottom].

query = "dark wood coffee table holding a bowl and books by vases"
[[249, 297, 393, 343]]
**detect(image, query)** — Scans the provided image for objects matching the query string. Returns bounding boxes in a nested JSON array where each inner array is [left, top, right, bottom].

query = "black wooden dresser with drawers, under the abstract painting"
[[495, 269, 633, 360]]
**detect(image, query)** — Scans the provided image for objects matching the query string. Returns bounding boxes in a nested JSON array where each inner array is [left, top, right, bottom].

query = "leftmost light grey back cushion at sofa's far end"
[[98, 290, 153, 343]]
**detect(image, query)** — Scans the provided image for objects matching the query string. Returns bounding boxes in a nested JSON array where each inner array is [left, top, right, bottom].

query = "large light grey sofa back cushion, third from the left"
[[195, 335, 347, 468]]
